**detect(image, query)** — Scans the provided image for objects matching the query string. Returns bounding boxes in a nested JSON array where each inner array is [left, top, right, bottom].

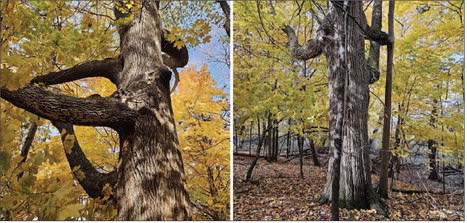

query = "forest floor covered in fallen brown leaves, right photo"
[[234, 156, 464, 221]]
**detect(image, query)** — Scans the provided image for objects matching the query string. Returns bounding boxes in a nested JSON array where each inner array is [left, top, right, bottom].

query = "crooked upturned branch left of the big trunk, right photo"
[[282, 26, 323, 60]]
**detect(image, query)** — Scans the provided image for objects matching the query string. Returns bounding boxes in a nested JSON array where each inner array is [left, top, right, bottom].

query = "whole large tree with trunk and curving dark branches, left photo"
[[1, 1, 200, 220]]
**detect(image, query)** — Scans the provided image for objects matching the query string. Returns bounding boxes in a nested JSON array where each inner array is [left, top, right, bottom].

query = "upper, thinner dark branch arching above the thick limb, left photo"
[[31, 58, 122, 85]]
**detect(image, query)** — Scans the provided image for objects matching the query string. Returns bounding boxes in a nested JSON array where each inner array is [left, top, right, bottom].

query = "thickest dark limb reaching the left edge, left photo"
[[0, 84, 136, 129]]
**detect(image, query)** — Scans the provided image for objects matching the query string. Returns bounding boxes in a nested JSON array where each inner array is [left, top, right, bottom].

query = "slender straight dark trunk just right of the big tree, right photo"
[[378, 1, 395, 198]]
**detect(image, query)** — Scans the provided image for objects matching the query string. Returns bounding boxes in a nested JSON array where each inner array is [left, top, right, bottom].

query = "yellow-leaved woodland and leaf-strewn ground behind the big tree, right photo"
[[234, 1, 465, 220]]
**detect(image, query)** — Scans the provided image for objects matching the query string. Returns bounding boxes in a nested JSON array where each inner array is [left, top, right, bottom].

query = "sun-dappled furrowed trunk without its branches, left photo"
[[115, 1, 191, 220]]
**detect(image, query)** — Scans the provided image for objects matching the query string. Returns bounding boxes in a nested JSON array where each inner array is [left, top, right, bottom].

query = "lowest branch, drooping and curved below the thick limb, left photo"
[[52, 122, 117, 199]]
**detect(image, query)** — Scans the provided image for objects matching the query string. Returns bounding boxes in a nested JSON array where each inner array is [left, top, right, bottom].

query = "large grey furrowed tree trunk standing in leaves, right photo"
[[288, 1, 389, 214]]
